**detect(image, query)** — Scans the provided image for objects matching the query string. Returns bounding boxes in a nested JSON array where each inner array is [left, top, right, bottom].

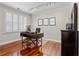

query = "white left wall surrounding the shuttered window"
[[0, 5, 31, 44]]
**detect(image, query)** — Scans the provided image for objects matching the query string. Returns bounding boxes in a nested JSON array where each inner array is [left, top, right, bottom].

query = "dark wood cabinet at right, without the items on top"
[[61, 30, 77, 56]]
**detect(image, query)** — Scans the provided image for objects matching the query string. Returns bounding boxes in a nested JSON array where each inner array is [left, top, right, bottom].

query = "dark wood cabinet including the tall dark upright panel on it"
[[61, 3, 79, 56]]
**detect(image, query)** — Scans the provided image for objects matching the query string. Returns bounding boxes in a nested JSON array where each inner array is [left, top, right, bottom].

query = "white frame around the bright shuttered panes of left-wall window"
[[5, 12, 27, 33]]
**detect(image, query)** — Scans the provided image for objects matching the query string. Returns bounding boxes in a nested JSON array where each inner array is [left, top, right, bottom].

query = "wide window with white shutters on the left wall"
[[6, 12, 27, 32]]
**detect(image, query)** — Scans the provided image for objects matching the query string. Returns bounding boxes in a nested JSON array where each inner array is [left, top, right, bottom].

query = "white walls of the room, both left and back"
[[0, 2, 72, 43]]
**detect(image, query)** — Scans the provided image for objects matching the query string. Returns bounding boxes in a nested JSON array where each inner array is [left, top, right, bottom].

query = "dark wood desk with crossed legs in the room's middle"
[[20, 32, 44, 47]]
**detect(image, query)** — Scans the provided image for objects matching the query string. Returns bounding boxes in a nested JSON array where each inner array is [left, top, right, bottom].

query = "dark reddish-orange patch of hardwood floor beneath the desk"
[[21, 47, 43, 56]]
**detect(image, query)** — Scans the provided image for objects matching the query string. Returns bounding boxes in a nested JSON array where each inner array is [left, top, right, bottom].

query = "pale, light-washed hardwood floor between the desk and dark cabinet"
[[42, 41, 61, 56]]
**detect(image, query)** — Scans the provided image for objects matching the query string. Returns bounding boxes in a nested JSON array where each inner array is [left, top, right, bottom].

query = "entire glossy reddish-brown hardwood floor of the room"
[[0, 41, 61, 56]]
